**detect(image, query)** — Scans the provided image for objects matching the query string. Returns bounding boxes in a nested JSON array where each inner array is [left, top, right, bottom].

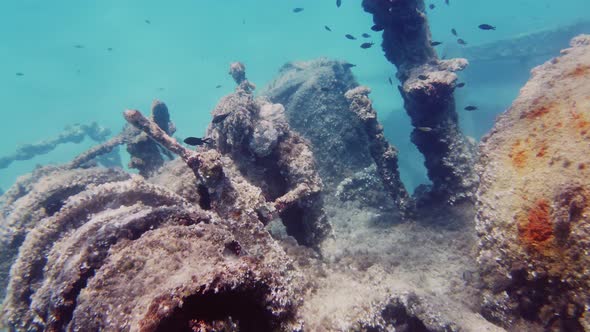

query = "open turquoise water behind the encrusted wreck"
[[0, 0, 590, 189]]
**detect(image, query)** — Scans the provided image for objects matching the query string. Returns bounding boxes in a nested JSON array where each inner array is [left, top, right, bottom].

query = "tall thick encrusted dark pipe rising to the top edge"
[[363, 0, 478, 204]]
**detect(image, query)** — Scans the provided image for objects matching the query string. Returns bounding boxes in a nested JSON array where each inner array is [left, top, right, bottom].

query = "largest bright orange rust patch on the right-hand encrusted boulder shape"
[[518, 199, 553, 246]]
